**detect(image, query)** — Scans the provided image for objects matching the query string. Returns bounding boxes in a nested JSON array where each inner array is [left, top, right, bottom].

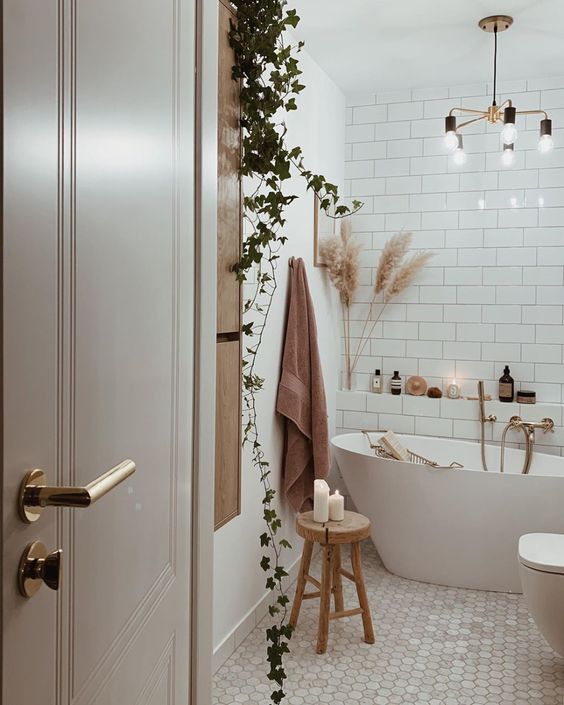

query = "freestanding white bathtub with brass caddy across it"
[[331, 433, 564, 592]]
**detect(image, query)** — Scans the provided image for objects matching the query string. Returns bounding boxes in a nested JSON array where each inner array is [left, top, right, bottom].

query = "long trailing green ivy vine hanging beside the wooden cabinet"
[[229, 0, 361, 703]]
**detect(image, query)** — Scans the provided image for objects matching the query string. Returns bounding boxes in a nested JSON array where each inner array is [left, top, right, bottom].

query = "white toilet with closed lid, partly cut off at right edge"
[[519, 534, 564, 656]]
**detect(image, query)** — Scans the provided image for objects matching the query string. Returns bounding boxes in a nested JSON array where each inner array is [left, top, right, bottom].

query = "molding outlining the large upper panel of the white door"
[[66, 0, 186, 705]]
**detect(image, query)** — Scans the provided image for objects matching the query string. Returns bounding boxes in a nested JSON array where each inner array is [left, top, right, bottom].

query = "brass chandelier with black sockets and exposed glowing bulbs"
[[445, 15, 554, 166]]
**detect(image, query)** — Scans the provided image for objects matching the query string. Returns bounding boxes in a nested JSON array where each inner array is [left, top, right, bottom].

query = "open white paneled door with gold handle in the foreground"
[[2, 0, 196, 705]]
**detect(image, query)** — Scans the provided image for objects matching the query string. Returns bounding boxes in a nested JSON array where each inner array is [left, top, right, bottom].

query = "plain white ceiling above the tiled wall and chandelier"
[[290, 0, 564, 94]]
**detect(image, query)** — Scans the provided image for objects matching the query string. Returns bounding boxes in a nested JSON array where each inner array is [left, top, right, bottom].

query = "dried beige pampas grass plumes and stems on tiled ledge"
[[319, 226, 433, 389]]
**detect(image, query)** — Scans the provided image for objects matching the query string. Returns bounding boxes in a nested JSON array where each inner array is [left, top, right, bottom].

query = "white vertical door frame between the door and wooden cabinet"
[[189, 0, 218, 705]]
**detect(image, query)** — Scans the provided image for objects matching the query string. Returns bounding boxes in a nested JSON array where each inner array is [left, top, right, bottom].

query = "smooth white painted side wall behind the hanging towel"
[[213, 53, 345, 665]]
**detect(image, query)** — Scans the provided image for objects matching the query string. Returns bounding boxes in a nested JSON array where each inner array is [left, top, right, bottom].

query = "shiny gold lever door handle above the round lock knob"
[[19, 460, 135, 524]]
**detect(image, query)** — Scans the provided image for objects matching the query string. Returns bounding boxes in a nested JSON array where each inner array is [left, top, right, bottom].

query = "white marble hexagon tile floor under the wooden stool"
[[213, 541, 564, 705]]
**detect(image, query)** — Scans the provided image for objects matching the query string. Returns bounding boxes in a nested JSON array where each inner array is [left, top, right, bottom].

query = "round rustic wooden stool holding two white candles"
[[290, 512, 374, 654]]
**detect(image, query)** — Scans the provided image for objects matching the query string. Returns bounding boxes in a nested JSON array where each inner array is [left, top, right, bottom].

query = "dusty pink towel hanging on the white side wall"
[[276, 259, 330, 512]]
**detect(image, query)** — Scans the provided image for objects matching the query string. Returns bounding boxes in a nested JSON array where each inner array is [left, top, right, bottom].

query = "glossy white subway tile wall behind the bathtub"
[[339, 77, 564, 404]]
